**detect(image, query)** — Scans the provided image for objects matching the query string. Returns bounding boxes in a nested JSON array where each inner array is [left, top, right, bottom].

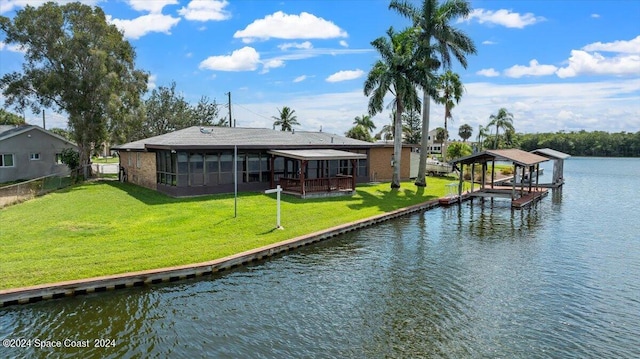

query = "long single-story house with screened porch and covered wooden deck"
[[112, 126, 416, 197]]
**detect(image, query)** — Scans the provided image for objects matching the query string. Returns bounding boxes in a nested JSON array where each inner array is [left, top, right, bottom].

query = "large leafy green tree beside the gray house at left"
[[0, 2, 147, 170]]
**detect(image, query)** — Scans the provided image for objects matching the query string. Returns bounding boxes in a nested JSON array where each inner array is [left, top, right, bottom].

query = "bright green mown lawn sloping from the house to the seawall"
[[0, 177, 454, 289]]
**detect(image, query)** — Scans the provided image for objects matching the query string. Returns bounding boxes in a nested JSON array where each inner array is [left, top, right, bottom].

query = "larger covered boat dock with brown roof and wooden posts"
[[453, 149, 549, 208]]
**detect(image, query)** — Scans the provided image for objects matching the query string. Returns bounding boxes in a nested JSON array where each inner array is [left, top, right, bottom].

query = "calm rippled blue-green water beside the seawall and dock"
[[0, 158, 640, 358]]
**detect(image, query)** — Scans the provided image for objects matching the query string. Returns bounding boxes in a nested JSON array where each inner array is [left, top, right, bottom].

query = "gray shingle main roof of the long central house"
[[113, 126, 372, 151]]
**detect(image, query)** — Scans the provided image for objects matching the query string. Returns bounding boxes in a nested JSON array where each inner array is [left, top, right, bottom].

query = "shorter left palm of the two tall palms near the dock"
[[364, 27, 420, 188]]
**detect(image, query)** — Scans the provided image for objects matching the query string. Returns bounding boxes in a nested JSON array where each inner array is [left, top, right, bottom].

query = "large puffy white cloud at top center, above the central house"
[[233, 11, 347, 43]]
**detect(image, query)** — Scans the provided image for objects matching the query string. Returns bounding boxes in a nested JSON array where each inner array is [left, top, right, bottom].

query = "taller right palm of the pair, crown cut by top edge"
[[389, 0, 476, 187]]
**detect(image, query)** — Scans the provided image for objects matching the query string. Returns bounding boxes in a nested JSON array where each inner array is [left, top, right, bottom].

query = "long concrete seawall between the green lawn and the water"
[[0, 199, 450, 307]]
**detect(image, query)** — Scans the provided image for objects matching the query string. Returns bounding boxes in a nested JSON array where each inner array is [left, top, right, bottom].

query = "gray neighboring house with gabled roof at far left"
[[0, 125, 78, 183]]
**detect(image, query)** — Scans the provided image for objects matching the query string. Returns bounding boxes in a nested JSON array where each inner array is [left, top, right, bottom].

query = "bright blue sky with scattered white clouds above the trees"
[[0, 0, 640, 138]]
